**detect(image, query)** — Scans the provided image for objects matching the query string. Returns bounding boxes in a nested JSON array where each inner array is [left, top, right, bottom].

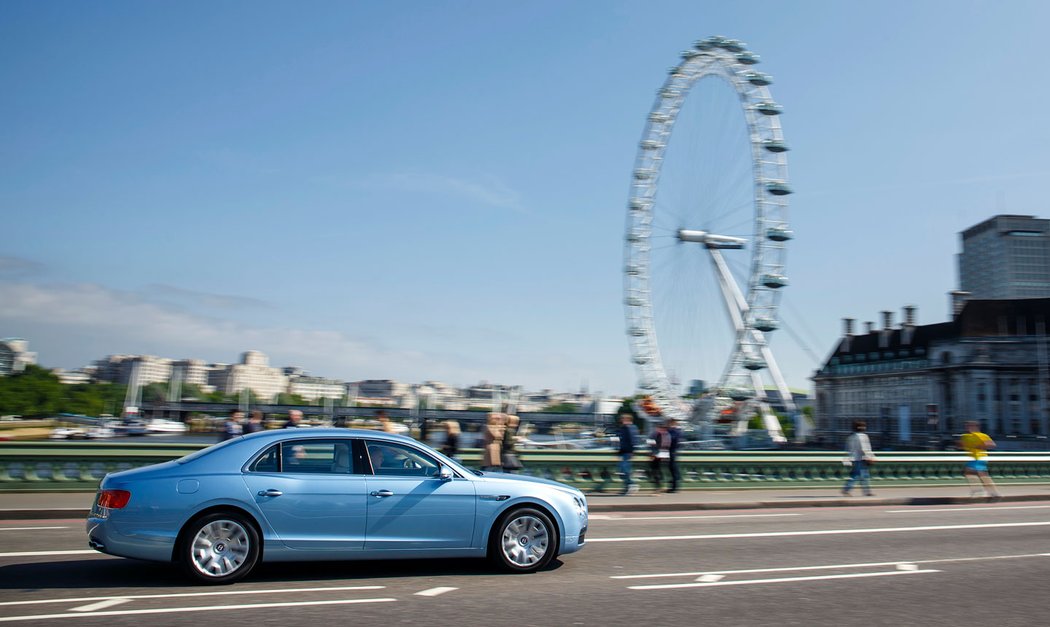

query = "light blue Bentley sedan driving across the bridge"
[[87, 429, 587, 584]]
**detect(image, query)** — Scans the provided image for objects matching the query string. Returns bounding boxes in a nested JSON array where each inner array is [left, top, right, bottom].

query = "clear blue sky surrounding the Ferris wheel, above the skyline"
[[0, 1, 1050, 394]]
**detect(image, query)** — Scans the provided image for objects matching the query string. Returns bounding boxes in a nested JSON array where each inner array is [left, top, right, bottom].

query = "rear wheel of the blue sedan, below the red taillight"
[[179, 511, 259, 585]]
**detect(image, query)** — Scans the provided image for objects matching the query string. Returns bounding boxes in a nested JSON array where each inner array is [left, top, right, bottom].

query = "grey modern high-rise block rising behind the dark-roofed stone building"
[[958, 215, 1050, 299]]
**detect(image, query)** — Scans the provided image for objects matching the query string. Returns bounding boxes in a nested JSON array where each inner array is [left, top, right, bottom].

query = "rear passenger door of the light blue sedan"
[[244, 438, 368, 549]]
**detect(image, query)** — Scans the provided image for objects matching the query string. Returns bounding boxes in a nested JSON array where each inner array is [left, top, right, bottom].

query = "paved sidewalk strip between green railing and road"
[[0, 483, 1050, 520]]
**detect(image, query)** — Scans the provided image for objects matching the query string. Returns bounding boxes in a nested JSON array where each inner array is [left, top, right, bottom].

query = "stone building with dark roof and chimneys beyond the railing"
[[813, 292, 1050, 446]]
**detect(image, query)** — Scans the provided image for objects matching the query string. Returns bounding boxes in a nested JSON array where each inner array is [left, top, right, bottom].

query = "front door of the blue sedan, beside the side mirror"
[[364, 440, 477, 549]]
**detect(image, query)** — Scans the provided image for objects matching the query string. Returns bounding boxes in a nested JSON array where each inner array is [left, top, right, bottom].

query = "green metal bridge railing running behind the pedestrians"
[[0, 441, 1050, 492]]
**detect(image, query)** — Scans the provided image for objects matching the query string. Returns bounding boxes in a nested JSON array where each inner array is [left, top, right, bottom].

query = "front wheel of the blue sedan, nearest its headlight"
[[488, 507, 559, 573]]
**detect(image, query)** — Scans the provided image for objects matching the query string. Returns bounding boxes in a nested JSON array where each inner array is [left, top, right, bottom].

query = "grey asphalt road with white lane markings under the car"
[[0, 501, 1050, 626]]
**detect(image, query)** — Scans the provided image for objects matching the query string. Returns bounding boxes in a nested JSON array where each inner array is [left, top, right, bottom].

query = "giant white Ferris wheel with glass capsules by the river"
[[624, 37, 795, 429]]
